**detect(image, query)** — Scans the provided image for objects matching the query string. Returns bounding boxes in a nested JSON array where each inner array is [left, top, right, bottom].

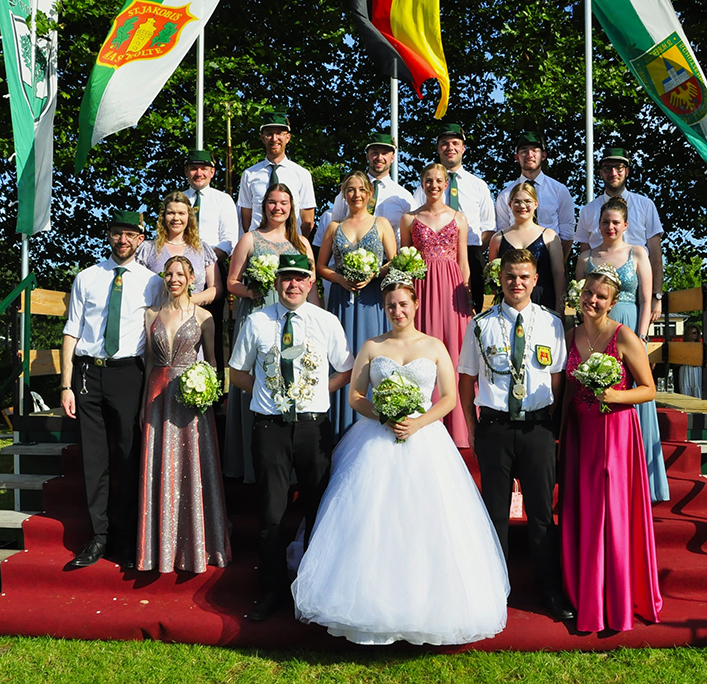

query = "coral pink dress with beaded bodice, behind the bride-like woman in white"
[[411, 219, 469, 448]]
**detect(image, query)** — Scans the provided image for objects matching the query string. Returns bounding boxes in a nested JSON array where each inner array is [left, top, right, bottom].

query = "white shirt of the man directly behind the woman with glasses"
[[496, 171, 575, 240]]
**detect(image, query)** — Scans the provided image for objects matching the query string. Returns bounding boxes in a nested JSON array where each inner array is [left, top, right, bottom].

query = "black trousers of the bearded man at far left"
[[72, 357, 143, 546]]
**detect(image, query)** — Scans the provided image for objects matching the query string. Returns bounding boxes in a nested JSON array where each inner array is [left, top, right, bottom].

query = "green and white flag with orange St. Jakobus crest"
[[76, 0, 218, 173]]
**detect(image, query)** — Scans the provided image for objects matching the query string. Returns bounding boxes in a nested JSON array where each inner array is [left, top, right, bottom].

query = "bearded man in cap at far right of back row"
[[575, 147, 663, 322]]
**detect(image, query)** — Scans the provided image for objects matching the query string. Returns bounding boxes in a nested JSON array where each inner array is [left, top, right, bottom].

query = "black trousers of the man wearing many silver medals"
[[252, 414, 334, 592]]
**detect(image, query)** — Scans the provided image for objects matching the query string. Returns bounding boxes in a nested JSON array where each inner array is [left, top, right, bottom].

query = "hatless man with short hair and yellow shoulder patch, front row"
[[458, 249, 574, 620]]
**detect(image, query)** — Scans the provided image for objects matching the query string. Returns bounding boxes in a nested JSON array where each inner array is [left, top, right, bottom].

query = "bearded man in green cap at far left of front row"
[[61, 211, 163, 568]]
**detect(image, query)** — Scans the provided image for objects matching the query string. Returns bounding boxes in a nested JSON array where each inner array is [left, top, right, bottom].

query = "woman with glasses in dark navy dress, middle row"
[[489, 181, 565, 312]]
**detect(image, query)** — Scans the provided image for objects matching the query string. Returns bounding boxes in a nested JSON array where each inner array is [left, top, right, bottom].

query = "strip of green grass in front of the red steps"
[[0, 637, 707, 684]]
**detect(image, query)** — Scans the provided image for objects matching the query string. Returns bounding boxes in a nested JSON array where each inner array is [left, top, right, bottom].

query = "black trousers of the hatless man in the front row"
[[474, 409, 562, 595]]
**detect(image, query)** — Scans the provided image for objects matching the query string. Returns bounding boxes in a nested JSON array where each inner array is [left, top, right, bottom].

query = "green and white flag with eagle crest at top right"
[[592, 0, 707, 161]]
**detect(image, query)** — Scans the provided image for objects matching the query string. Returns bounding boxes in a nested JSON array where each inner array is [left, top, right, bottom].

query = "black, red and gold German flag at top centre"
[[351, 0, 449, 119]]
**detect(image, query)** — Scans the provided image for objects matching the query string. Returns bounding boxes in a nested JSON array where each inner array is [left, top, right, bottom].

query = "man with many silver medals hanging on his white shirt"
[[229, 254, 354, 620]]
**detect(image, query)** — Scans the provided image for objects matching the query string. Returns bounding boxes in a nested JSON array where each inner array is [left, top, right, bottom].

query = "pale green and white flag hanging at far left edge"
[[0, 0, 57, 235]]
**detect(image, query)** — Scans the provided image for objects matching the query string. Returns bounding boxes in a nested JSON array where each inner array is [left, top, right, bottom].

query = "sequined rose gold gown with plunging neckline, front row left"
[[137, 315, 231, 572]]
